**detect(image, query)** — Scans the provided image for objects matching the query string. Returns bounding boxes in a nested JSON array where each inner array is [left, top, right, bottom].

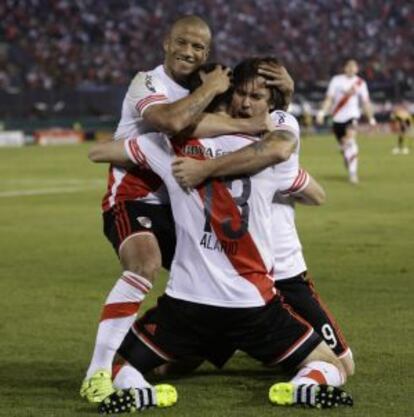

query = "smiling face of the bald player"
[[164, 24, 210, 81]]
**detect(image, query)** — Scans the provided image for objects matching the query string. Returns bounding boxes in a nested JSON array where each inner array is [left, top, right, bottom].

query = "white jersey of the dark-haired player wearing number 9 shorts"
[[271, 111, 307, 280]]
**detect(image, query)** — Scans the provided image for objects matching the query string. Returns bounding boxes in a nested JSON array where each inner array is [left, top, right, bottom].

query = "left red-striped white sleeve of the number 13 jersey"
[[124, 132, 175, 180]]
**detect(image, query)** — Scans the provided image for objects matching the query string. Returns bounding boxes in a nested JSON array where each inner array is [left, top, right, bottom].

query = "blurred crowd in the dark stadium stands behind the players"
[[0, 0, 414, 141]]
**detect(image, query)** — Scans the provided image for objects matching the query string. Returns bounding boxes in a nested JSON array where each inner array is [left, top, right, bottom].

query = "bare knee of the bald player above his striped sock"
[[119, 234, 162, 282]]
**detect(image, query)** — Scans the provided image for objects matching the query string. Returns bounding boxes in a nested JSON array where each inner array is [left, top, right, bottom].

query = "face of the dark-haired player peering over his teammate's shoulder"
[[230, 77, 270, 118]]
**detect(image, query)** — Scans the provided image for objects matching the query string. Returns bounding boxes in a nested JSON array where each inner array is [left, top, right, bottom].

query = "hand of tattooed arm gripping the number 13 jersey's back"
[[172, 157, 208, 190]]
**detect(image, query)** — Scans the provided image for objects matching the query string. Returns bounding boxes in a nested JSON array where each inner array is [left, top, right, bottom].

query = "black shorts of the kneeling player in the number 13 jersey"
[[118, 295, 321, 371]]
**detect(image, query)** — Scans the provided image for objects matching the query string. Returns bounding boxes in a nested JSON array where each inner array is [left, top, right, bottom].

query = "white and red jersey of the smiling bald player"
[[102, 65, 188, 211]]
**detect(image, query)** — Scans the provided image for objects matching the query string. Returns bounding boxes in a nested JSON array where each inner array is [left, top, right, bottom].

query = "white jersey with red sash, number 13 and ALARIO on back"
[[125, 110, 298, 307]]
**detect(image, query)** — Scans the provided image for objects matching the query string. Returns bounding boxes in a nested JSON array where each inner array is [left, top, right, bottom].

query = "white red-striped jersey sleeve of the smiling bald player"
[[125, 72, 170, 117]]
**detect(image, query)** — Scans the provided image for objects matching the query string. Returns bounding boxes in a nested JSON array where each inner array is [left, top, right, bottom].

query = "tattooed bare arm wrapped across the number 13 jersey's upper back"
[[172, 130, 297, 188]]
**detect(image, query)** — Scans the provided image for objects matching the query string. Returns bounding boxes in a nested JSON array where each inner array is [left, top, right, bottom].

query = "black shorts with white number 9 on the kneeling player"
[[275, 273, 349, 356]]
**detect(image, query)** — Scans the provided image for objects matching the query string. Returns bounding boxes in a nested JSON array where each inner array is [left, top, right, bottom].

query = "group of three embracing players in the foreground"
[[81, 16, 353, 413]]
